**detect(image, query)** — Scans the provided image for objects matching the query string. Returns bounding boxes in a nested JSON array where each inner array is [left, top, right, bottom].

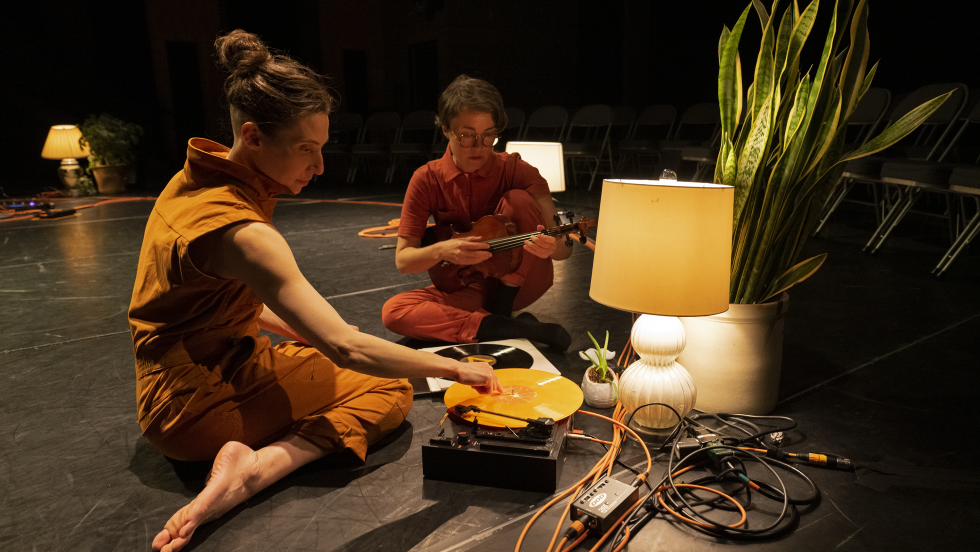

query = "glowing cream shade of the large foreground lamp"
[[589, 180, 735, 316]]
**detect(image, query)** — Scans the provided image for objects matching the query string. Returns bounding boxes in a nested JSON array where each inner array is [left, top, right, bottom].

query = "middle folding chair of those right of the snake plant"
[[864, 83, 969, 253]]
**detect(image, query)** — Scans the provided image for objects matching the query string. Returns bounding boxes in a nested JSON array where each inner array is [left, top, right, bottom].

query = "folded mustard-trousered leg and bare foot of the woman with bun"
[[153, 338, 412, 549]]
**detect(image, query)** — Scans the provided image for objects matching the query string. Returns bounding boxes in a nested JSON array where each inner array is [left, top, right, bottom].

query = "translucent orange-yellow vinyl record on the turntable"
[[445, 368, 582, 428]]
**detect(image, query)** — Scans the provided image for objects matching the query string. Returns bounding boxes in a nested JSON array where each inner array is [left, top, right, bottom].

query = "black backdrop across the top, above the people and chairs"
[[0, 0, 980, 195]]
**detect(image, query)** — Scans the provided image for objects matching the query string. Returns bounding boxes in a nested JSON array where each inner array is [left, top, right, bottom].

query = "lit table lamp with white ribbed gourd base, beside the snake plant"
[[589, 180, 735, 429]]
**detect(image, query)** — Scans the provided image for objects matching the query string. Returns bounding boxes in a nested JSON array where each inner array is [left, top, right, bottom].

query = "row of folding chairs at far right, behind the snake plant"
[[815, 83, 980, 276]]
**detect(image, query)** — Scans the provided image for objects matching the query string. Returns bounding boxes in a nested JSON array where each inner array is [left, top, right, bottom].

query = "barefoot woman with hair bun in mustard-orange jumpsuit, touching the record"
[[129, 30, 500, 552]]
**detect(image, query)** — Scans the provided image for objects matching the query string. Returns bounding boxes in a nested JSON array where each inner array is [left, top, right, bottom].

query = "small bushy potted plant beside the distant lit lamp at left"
[[79, 113, 143, 194]]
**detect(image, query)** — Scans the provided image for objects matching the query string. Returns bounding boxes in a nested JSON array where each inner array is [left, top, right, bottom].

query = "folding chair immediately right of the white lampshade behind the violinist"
[[561, 104, 613, 191]]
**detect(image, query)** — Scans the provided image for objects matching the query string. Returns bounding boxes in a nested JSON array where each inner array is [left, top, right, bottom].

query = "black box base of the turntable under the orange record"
[[422, 417, 571, 493]]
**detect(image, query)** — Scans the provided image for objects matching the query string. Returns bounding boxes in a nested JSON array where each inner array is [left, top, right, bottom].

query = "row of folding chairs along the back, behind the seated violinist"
[[323, 103, 719, 190]]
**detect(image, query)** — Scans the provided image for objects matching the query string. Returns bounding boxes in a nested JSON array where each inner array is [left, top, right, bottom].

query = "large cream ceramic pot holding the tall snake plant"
[[677, 293, 789, 415]]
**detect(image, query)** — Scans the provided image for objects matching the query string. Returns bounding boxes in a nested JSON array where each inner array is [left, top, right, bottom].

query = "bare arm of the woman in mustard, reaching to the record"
[[207, 223, 500, 392]]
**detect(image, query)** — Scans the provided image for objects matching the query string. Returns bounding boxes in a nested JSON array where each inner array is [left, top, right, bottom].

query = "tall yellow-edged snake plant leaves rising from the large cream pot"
[[714, 0, 951, 304]]
